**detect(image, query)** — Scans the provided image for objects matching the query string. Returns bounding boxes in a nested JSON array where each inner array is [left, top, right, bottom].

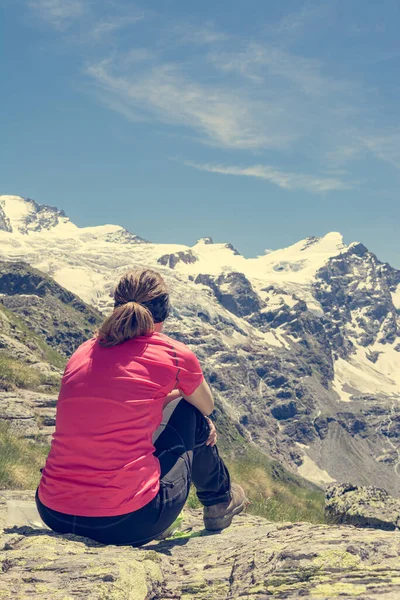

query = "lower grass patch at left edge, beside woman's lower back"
[[0, 422, 49, 490]]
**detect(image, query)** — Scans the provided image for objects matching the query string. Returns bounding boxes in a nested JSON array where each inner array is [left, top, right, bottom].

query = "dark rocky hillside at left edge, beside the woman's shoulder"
[[0, 261, 102, 398]]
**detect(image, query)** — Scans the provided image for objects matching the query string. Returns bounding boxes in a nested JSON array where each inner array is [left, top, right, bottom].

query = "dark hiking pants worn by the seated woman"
[[36, 400, 230, 546]]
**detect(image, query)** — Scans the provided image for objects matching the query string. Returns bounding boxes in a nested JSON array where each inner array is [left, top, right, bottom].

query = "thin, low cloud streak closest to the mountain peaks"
[[184, 161, 351, 194]]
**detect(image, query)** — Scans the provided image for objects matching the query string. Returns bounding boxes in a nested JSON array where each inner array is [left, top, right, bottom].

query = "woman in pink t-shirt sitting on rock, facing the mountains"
[[36, 269, 245, 546]]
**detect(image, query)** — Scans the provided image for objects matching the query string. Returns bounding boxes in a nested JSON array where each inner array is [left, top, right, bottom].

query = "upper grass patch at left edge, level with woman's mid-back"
[[0, 351, 60, 393]]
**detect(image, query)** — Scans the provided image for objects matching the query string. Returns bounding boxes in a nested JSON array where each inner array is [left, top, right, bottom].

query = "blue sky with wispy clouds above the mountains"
[[0, 0, 400, 268]]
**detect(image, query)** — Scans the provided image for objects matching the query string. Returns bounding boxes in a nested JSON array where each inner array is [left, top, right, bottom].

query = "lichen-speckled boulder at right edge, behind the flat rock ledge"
[[325, 484, 400, 530]]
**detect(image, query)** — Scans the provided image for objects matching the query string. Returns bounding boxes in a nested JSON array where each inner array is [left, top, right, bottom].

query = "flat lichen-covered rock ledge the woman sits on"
[[0, 491, 400, 600]]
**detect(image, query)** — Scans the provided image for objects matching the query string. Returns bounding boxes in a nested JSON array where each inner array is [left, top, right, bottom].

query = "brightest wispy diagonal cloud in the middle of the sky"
[[86, 61, 295, 149]]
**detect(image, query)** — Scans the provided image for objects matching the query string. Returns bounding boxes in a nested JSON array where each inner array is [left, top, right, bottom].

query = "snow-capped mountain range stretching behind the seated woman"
[[0, 196, 400, 494]]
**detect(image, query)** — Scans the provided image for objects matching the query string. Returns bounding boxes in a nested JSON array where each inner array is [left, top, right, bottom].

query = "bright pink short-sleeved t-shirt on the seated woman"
[[38, 333, 203, 517]]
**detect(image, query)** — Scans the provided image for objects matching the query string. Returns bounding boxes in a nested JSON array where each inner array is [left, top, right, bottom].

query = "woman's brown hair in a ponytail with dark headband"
[[97, 269, 169, 348]]
